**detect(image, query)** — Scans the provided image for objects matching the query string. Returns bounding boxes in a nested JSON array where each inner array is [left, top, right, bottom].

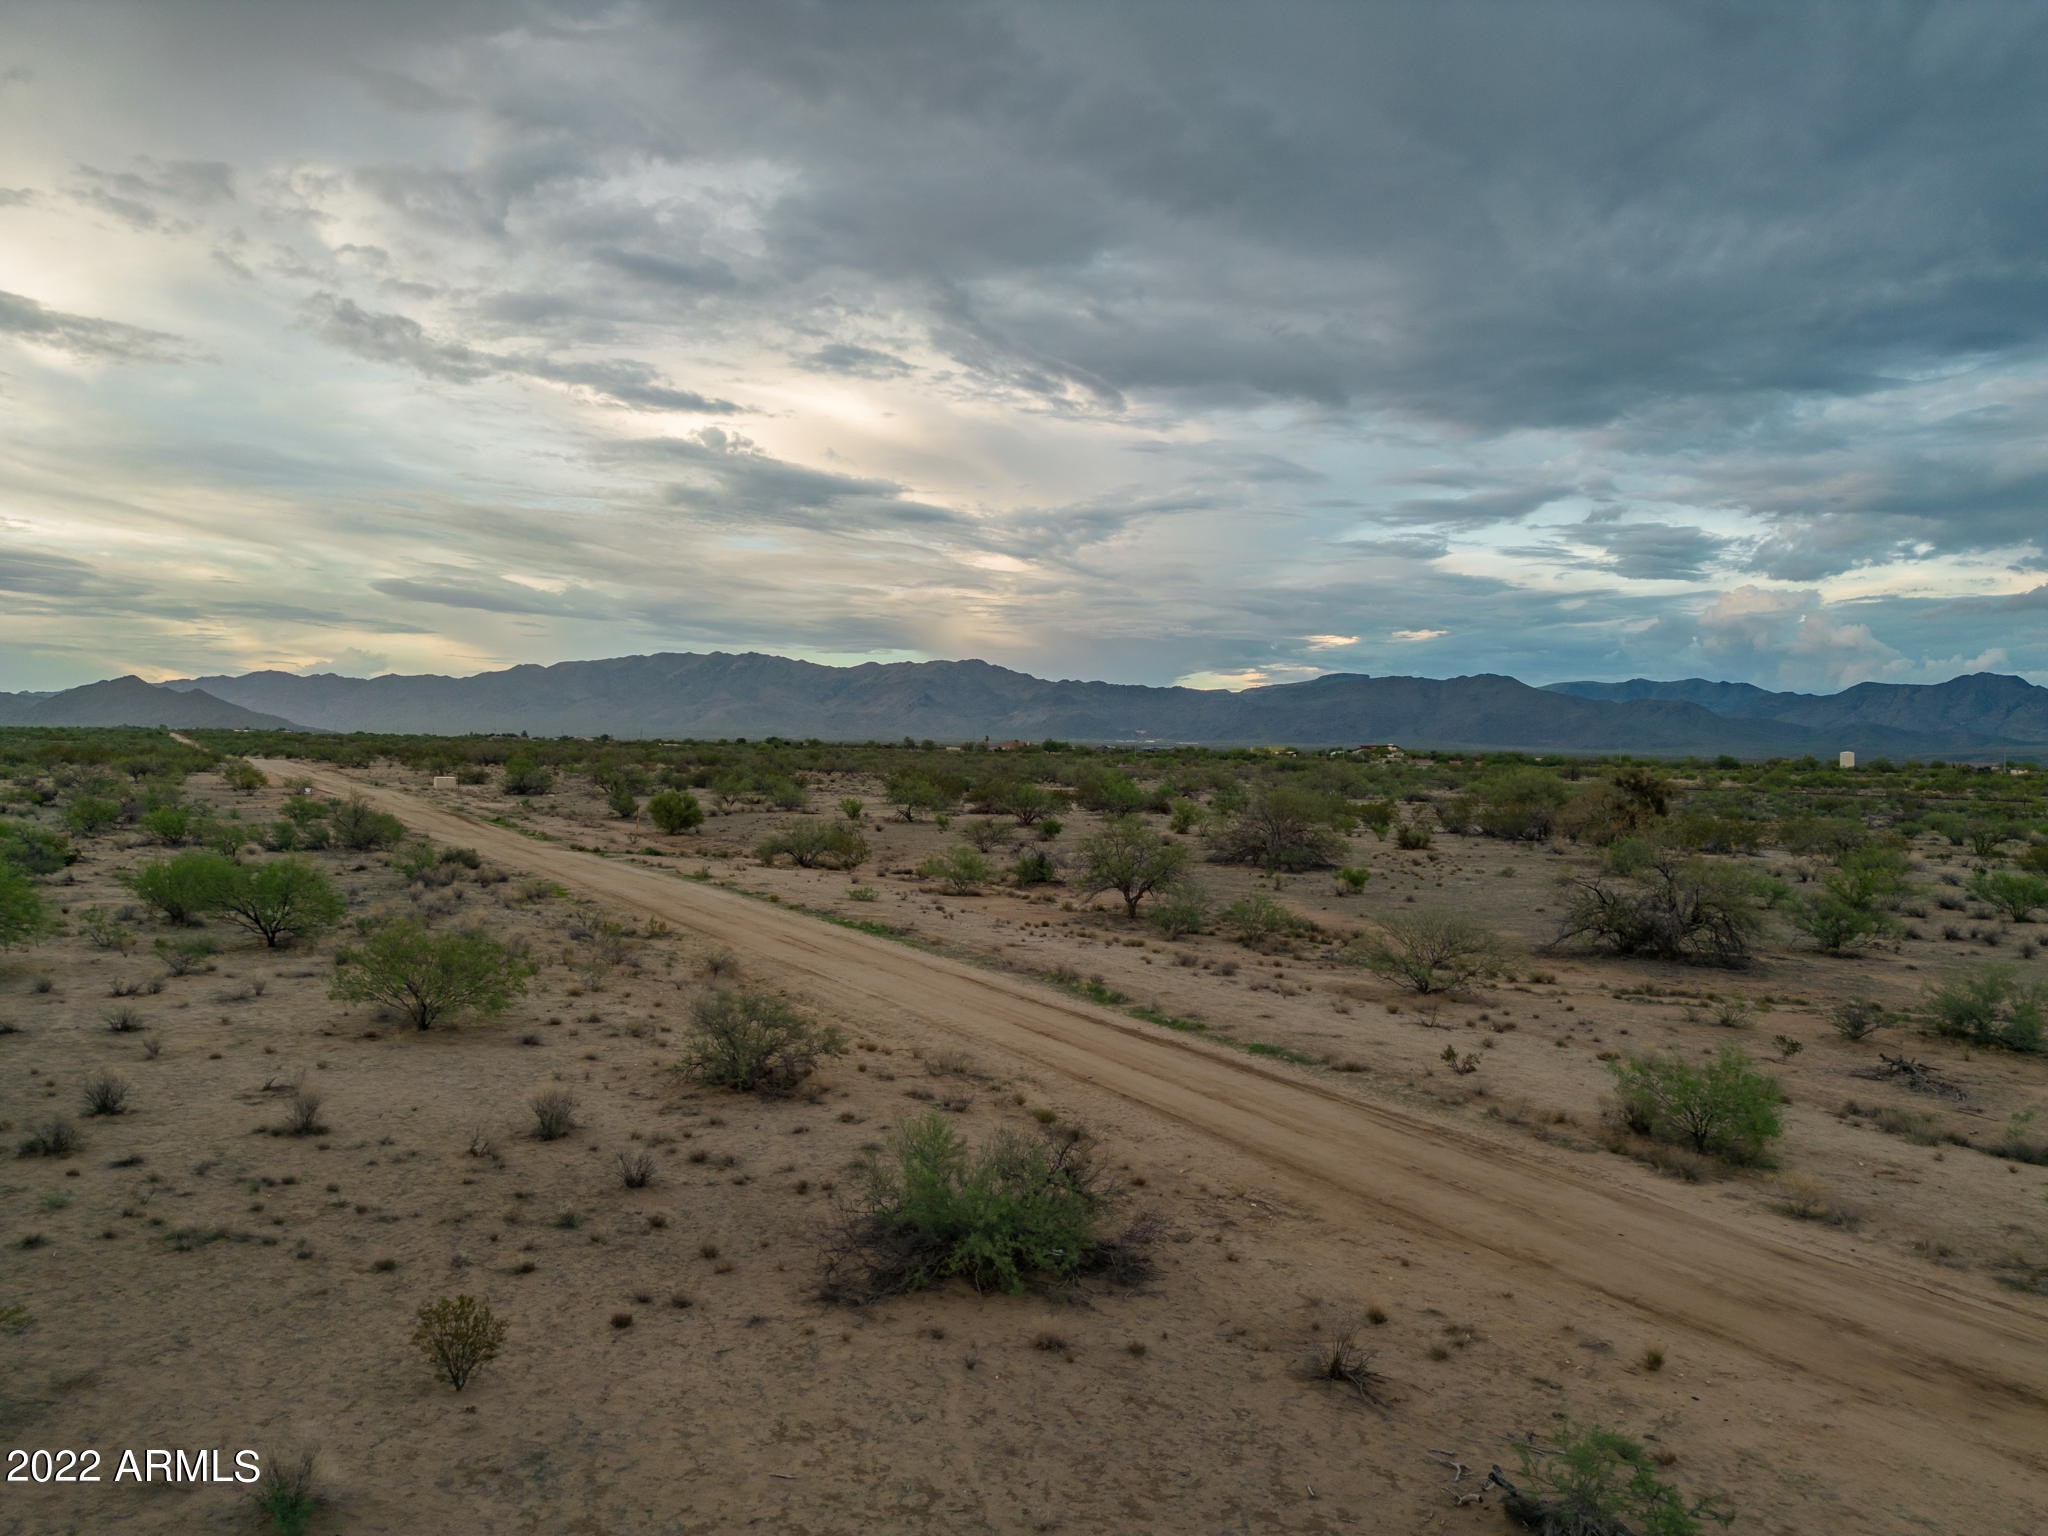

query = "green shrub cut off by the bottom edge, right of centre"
[[1503, 1423, 1733, 1536]]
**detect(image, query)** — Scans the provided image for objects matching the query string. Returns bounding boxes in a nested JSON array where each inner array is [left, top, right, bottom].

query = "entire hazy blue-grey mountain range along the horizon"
[[0, 651, 2048, 758]]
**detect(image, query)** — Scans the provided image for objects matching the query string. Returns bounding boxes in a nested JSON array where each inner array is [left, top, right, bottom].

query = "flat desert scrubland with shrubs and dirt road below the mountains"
[[0, 731, 2048, 1534]]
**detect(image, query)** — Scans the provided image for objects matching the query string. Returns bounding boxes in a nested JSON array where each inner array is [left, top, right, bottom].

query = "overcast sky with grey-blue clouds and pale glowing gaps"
[[0, 0, 2048, 688]]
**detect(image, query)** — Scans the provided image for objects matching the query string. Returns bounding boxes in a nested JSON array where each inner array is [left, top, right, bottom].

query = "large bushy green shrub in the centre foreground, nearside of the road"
[[825, 1112, 1110, 1300]]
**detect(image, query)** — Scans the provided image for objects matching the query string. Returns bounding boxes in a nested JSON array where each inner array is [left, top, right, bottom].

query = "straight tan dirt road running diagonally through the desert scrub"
[[260, 762, 2048, 1507]]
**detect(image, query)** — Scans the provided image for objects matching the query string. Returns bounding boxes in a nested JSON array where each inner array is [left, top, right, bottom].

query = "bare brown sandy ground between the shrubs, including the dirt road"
[[0, 764, 2048, 1534]]
